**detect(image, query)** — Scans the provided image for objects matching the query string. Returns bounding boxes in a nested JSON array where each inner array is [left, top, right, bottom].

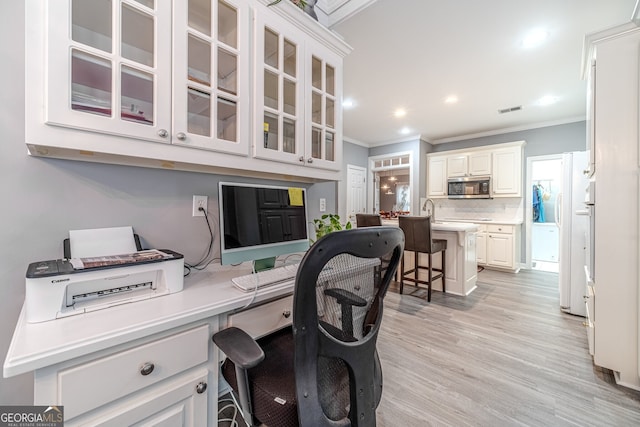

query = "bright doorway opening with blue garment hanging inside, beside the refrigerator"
[[525, 155, 562, 273]]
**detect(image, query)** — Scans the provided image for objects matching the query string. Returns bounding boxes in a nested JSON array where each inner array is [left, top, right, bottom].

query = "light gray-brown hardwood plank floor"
[[378, 270, 640, 427]]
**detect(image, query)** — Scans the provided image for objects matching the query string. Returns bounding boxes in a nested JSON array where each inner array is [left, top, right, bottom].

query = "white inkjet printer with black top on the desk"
[[25, 229, 184, 323]]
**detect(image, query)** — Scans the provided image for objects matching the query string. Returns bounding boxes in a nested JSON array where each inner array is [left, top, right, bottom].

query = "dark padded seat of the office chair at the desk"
[[222, 327, 299, 427]]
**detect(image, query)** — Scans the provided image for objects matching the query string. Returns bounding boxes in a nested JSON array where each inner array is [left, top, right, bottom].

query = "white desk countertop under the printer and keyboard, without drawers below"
[[3, 264, 294, 378]]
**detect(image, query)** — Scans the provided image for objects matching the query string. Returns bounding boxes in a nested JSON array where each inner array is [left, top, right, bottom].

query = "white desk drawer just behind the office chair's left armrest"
[[227, 295, 293, 338]]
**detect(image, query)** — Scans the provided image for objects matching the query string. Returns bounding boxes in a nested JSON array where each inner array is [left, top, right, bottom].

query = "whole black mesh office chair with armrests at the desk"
[[213, 227, 404, 427]]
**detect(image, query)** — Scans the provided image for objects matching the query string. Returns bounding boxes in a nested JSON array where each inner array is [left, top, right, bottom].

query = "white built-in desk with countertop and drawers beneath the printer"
[[3, 265, 293, 426]]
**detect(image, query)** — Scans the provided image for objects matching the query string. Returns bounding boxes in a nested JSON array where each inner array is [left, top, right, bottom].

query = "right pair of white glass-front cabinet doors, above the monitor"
[[254, 10, 342, 170]]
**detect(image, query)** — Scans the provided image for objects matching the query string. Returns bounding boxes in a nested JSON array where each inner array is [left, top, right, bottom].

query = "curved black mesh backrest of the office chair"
[[293, 227, 404, 427]]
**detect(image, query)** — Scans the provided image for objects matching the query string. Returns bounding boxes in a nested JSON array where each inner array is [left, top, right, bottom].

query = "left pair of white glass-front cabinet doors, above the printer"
[[45, 0, 249, 155]]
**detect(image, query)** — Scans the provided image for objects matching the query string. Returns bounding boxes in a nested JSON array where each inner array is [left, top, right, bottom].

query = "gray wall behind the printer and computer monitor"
[[0, 1, 337, 405]]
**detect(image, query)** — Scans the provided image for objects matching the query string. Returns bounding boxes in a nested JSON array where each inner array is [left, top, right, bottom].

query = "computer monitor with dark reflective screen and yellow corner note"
[[218, 182, 309, 264]]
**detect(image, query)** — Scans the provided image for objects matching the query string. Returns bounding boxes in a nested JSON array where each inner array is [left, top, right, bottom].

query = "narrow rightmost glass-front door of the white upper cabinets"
[[305, 41, 342, 170]]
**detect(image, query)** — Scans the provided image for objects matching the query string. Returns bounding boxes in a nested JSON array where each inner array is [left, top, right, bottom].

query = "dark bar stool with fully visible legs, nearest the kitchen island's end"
[[398, 216, 447, 302]]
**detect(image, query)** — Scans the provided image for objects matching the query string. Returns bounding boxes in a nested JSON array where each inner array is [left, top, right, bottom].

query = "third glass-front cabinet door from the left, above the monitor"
[[254, 11, 305, 163]]
